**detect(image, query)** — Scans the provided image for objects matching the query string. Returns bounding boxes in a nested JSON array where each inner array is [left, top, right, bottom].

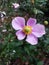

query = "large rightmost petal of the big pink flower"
[[32, 24, 45, 37]]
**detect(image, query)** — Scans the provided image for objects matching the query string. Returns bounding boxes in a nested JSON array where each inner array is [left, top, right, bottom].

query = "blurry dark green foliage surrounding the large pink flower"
[[0, 0, 49, 65]]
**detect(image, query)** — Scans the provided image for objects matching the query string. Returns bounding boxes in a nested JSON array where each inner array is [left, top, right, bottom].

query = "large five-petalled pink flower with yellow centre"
[[12, 17, 45, 45]]
